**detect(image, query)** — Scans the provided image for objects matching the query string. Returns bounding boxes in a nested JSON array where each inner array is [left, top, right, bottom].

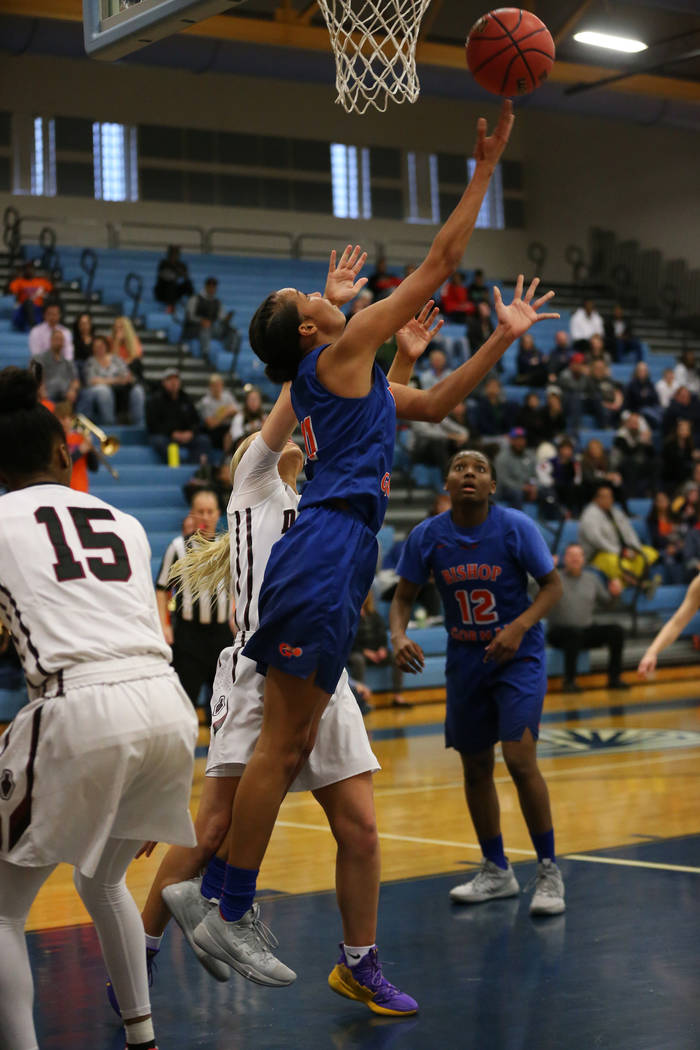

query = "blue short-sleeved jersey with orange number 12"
[[397, 505, 554, 656]]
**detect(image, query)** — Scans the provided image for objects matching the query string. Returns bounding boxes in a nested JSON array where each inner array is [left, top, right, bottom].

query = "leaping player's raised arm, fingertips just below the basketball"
[[332, 99, 513, 362]]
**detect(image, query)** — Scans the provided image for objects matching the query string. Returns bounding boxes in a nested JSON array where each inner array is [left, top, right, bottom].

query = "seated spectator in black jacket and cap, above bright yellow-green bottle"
[[146, 369, 211, 463]]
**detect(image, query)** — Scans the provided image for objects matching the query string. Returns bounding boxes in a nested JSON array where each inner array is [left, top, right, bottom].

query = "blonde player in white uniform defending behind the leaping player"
[[128, 279, 440, 1016]]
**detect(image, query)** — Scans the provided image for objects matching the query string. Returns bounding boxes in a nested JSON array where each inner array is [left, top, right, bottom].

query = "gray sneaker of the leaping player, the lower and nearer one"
[[194, 904, 297, 988]]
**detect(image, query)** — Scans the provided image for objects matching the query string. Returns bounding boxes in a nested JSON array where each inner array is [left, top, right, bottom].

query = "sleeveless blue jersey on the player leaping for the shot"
[[292, 347, 396, 532]]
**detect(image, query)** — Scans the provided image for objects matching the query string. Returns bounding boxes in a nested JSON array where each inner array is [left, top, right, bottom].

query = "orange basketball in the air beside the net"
[[466, 7, 554, 98]]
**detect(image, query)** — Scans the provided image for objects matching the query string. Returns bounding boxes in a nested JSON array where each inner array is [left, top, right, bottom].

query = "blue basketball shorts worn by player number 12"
[[445, 646, 547, 755]]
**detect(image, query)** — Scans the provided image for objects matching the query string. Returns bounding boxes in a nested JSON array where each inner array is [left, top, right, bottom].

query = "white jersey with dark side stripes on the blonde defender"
[[227, 435, 299, 643]]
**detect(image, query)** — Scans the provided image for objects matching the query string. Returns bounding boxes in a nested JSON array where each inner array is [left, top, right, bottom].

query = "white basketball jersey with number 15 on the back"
[[0, 484, 170, 688]]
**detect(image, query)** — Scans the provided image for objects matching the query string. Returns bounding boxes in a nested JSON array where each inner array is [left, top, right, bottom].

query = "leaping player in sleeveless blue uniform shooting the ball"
[[194, 102, 557, 982]]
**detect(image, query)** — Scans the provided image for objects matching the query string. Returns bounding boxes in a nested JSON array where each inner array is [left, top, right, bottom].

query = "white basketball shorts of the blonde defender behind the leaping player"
[[207, 646, 381, 791]]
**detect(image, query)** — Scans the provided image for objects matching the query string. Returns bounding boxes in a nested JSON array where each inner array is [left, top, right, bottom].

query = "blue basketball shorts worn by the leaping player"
[[243, 504, 377, 694]]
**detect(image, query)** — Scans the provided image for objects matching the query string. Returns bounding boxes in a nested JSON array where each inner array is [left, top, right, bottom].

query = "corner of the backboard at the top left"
[[83, 0, 242, 61]]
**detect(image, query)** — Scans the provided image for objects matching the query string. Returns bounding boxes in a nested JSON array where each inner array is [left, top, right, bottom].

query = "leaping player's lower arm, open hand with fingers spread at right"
[[388, 274, 559, 423]]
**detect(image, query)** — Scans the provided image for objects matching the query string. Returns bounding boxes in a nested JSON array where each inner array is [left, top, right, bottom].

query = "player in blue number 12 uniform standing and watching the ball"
[[389, 452, 565, 915]]
